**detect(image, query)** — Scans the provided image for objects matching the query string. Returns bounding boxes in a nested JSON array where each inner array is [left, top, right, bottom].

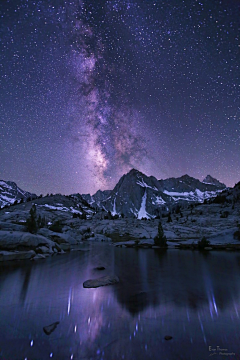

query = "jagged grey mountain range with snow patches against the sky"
[[0, 169, 226, 219]]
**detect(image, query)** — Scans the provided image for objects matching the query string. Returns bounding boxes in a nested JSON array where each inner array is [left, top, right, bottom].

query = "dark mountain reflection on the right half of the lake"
[[115, 248, 239, 315]]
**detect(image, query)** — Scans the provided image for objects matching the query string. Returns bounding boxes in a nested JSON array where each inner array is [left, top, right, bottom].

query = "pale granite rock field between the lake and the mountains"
[[0, 200, 240, 261]]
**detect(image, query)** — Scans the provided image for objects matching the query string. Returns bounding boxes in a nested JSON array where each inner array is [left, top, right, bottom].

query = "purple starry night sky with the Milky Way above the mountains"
[[0, 0, 240, 194]]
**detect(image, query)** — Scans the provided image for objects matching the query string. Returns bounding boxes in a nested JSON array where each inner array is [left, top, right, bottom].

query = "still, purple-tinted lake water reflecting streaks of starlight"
[[0, 243, 240, 360]]
